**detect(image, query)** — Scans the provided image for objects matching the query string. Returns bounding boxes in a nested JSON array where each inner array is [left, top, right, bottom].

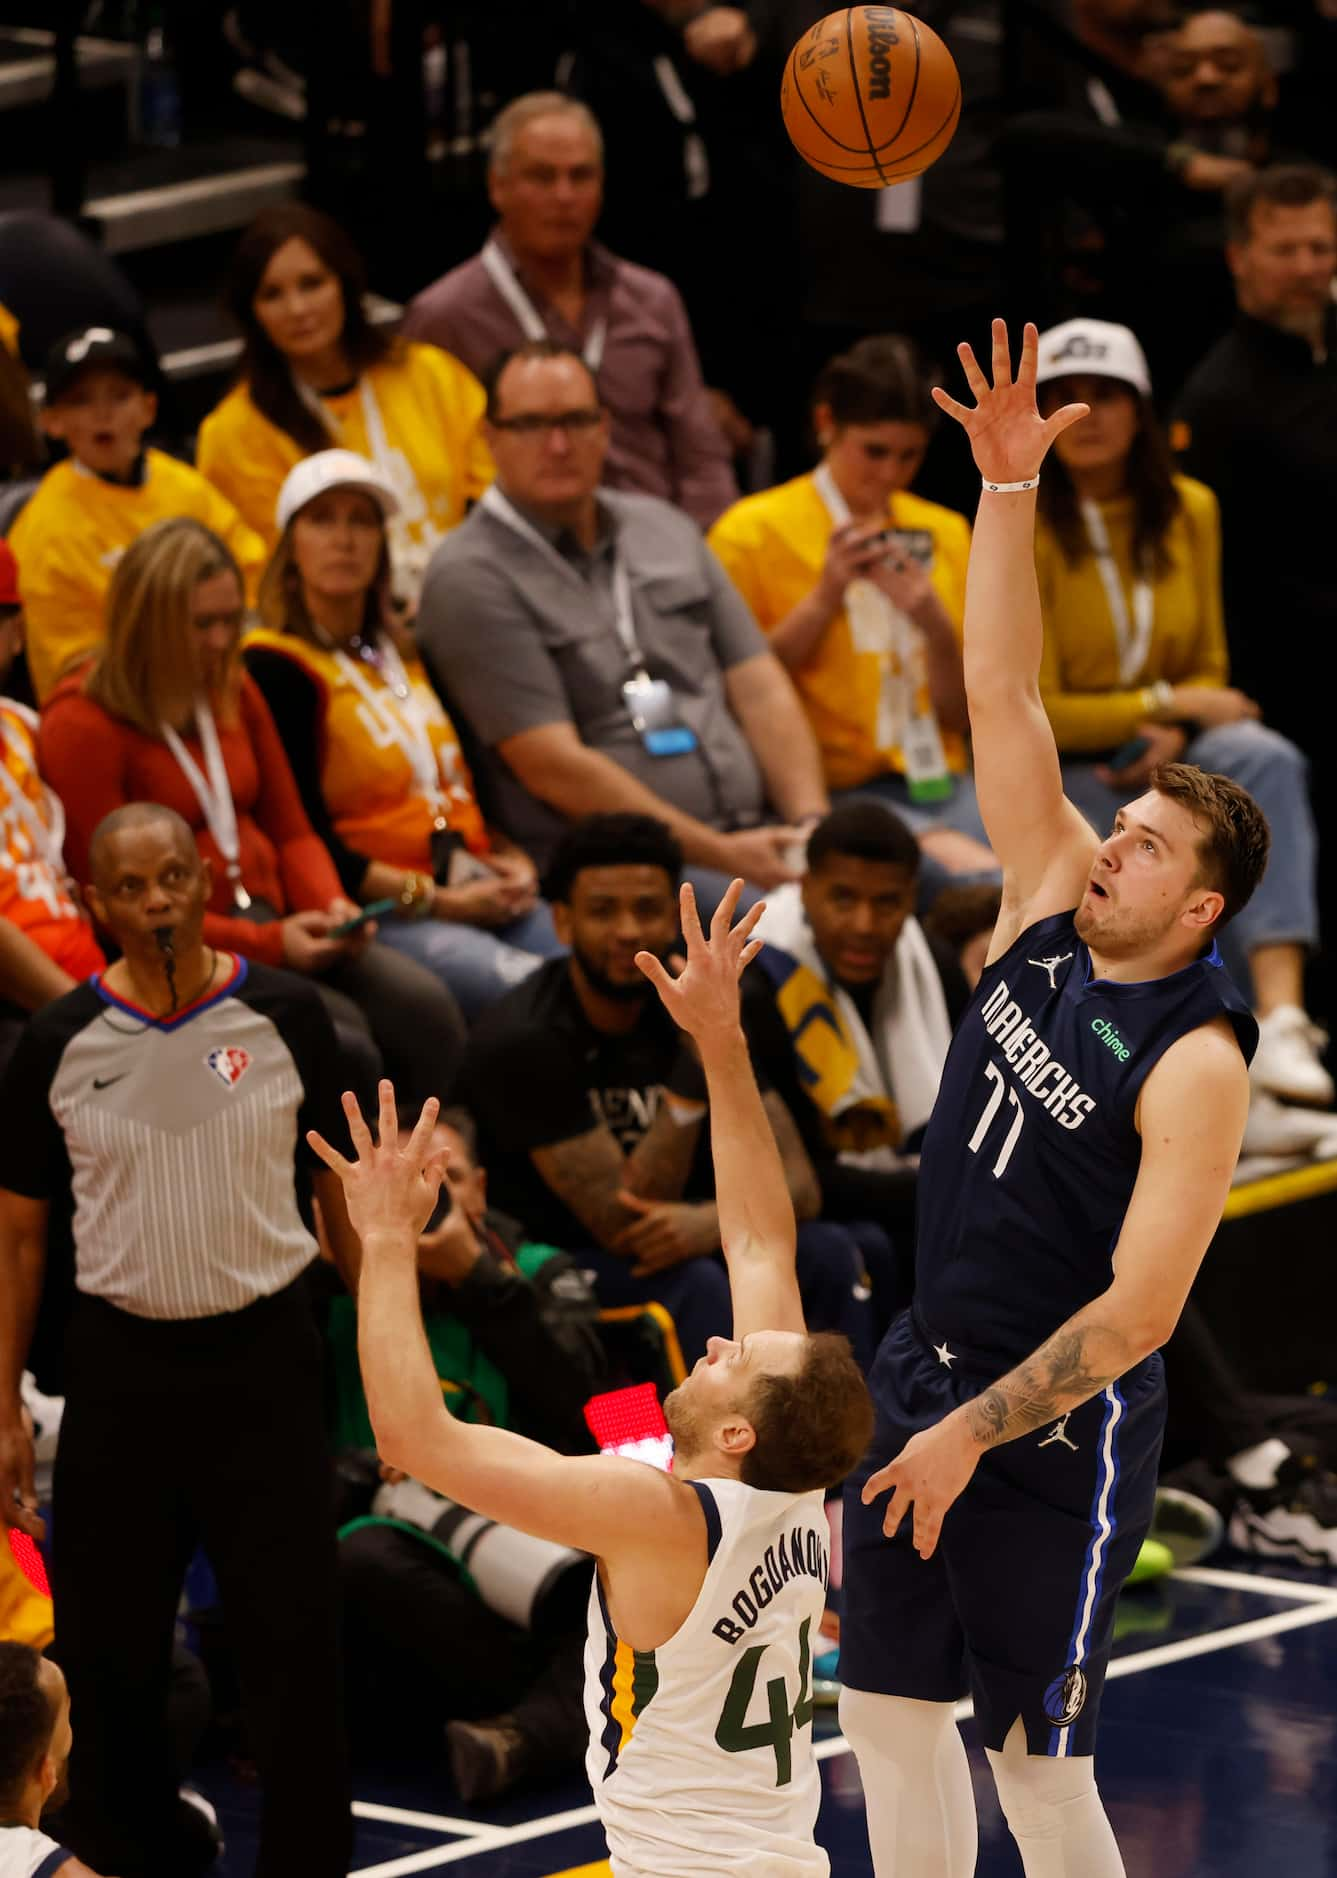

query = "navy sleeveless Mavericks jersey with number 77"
[[914, 913, 1258, 1363]]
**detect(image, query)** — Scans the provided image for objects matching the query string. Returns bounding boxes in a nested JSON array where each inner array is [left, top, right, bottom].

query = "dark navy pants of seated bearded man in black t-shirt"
[[576, 1219, 873, 1369]]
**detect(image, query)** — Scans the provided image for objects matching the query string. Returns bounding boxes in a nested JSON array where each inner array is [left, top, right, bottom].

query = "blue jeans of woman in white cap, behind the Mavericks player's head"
[[1063, 719, 1318, 990]]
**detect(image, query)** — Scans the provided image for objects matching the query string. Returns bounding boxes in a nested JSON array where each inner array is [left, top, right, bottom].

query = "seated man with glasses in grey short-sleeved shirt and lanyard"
[[419, 340, 826, 905]]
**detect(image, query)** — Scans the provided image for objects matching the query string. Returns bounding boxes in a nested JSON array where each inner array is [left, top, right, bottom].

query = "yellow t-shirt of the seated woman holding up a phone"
[[706, 475, 971, 789]]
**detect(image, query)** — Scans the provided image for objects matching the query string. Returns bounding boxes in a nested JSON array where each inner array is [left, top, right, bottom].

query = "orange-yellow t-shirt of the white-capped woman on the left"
[[246, 627, 488, 873]]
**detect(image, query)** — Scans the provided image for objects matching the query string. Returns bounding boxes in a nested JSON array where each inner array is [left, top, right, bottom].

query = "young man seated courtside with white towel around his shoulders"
[[744, 800, 967, 1330]]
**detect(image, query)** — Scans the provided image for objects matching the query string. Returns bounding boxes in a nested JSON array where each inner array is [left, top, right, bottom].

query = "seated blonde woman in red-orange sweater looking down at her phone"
[[38, 516, 464, 1099]]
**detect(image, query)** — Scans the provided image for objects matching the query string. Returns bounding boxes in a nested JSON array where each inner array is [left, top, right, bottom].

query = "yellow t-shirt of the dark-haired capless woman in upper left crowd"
[[195, 344, 494, 560]]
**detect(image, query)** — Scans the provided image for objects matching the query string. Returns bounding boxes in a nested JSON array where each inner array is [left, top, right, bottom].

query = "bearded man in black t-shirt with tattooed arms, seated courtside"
[[464, 815, 871, 1365]]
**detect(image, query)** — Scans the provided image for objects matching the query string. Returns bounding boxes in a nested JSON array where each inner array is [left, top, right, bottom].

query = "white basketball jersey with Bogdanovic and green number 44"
[[586, 1480, 830, 1878]]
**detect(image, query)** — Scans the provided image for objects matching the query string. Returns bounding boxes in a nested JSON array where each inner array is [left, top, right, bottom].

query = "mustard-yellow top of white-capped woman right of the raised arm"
[[1035, 475, 1228, 755]]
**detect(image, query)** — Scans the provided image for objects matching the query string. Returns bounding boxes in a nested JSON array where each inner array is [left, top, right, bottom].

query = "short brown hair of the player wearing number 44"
[[740, 1330, 873, 1493]]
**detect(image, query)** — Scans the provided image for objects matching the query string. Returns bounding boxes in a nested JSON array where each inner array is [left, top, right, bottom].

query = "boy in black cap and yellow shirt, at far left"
[[9, 327, 265, 704]]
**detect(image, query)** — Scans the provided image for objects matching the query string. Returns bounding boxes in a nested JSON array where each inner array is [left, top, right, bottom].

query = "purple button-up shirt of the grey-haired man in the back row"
[[404, 233, 738, 528]]
